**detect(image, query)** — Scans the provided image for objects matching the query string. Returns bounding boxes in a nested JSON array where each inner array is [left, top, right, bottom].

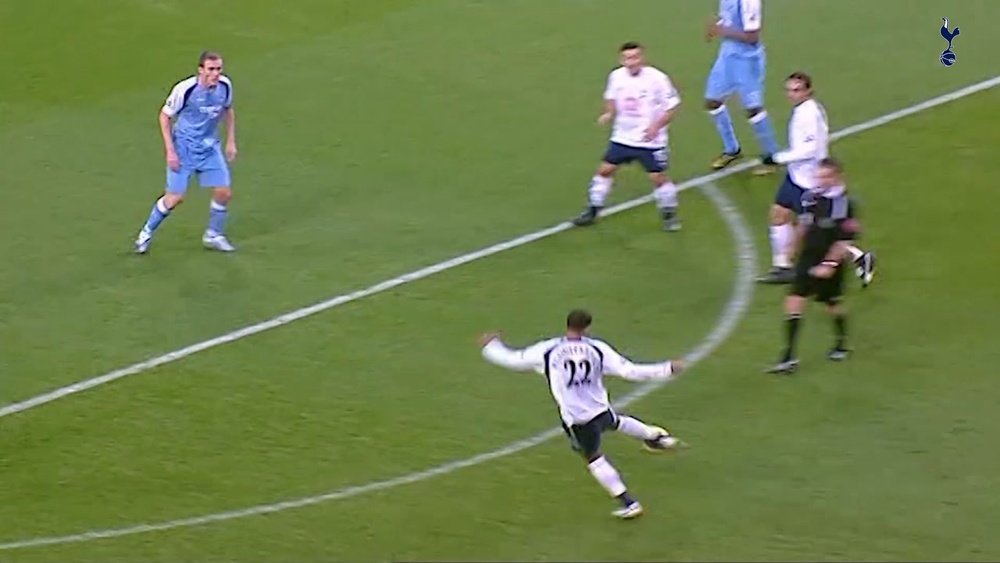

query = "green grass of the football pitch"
[[0, 0, 1000, 562]]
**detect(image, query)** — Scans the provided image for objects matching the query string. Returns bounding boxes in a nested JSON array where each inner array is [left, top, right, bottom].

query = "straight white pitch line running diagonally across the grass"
[[0, 76, 1000, 424]]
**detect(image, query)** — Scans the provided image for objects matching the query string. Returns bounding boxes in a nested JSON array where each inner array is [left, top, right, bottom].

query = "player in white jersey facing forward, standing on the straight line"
[[573, 42, 681, 231]]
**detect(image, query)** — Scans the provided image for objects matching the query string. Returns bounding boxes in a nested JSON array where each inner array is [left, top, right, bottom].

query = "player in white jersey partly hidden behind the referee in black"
[[758, 72, 875, 286]]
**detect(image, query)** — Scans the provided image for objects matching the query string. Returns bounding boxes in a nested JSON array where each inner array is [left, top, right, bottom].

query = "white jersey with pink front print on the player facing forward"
[[604, 66, 681, 149]]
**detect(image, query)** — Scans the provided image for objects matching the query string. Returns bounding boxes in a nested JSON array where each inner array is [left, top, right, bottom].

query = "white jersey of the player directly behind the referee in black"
[[773, 98, 830, 189]]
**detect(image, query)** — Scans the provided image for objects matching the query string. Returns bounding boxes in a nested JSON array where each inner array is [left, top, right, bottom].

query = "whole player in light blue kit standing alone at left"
[[135, 51, 236, 254]]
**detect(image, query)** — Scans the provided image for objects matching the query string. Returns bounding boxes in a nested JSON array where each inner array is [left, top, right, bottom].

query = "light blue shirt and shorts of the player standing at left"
[[162, 76, 233, 193]]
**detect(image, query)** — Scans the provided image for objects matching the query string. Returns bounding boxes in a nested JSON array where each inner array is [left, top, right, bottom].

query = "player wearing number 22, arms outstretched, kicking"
[[480, 309, 683, 519]]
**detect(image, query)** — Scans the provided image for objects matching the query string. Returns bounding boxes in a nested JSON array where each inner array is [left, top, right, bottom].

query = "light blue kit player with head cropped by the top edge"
[[705, 0, 778, 174]]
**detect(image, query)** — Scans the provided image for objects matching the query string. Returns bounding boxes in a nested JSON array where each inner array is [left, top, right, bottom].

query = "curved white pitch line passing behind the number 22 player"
[[0, 178, 757, 551]]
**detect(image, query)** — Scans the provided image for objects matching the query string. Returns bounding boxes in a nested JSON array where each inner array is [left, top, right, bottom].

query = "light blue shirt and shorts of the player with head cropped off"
[[705, 0, 766, 108]]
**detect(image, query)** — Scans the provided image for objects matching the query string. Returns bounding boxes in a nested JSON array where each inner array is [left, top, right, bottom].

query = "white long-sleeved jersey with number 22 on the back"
[[483, 337, 673, 425]]
